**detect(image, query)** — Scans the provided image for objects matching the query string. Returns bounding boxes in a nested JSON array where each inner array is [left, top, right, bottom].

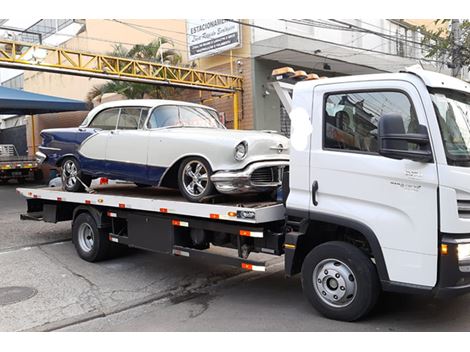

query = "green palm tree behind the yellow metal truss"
[[87, 38, 181, 102]]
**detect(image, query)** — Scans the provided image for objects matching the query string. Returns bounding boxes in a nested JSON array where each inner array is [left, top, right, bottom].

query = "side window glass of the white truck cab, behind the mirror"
[[323, 91, 419, 153]]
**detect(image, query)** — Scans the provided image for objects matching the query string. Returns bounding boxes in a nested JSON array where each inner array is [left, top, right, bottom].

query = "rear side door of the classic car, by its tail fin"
[[79, 108, 119, 176]]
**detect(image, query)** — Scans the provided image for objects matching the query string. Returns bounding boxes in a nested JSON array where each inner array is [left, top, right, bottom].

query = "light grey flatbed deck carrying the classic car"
[[17, 184, 285, 224]]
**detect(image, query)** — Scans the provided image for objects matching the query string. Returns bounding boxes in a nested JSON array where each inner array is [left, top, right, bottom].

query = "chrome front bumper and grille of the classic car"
[[211, 160, 289, 194]]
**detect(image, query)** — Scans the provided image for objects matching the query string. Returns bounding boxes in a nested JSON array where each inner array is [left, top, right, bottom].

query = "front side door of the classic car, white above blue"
[[106, 107, 148, 183]]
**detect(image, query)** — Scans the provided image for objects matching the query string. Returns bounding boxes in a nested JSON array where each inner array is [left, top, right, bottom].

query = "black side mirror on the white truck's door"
[[378, 114, 433, 163]]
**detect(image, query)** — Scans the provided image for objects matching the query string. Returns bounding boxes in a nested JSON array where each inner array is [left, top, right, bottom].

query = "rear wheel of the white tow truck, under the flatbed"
[[72, 213, 114, 262]]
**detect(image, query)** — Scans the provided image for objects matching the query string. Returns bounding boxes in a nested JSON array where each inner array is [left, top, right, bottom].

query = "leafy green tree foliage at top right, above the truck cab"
[[417, 19, 470, 66]]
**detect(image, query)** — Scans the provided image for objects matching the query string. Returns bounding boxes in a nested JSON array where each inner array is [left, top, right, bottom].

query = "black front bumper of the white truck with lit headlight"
[[433, 234, 470, 297]]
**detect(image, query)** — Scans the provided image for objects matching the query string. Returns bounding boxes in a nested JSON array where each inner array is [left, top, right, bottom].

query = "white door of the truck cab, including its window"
[[310, 80, 438, 286]]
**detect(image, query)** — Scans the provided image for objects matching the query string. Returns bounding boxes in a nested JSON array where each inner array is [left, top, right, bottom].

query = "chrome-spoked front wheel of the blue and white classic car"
[[178, 157, 214, 202]]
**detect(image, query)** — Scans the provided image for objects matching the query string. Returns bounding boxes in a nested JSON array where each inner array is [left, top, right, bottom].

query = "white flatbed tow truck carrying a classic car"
[[18, 68, 470, 321]]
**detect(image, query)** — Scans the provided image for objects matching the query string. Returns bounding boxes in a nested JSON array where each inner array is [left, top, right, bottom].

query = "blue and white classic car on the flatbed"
[[36, 99, 289, 202]]
